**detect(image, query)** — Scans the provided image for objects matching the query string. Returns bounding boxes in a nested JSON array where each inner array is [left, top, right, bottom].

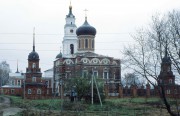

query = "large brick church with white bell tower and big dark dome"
[[54, 5, 122, 97]]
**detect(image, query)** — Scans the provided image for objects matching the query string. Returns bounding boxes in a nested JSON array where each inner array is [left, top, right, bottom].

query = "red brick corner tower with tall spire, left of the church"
[[22, 30, 48, 99]]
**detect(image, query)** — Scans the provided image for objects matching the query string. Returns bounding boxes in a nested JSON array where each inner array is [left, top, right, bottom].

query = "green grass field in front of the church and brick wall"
[[1, 96, 173, 116]]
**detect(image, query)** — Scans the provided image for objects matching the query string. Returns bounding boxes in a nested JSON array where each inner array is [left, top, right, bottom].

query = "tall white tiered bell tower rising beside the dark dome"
[[62, 6, 77, 55]]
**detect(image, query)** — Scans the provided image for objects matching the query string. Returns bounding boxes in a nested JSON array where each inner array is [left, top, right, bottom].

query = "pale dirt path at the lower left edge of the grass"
[[0, 97, 23, 116]]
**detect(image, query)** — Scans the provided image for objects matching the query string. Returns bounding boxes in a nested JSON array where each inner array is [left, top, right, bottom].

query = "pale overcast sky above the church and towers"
[[0, 0, 180, 73]]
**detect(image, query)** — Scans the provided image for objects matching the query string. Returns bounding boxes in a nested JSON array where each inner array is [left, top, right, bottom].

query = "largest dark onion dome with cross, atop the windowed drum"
[[76, 18, 96, 36]]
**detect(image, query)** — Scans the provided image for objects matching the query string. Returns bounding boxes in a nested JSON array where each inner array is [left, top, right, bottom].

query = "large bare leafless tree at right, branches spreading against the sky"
[[123, 10, 180, 115]]
